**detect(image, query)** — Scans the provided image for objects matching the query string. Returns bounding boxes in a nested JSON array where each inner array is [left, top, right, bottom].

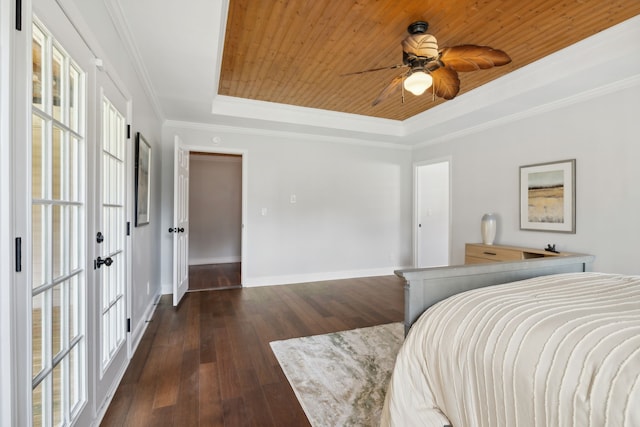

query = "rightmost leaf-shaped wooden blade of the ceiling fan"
[[440, 44, 511, 72]]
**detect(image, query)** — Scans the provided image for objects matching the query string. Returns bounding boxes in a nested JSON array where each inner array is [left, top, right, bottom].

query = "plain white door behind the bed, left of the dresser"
[[414, 160, 450, 268]]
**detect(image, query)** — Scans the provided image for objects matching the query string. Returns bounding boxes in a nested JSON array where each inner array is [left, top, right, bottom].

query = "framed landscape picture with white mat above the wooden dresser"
[[520, 159, 576, 233]]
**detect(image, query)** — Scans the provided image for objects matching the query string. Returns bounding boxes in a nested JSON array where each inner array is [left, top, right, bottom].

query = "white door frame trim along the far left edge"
[[0, 0, 26, 425]]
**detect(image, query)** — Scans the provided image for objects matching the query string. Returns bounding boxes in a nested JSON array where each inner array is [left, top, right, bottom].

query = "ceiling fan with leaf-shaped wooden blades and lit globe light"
[[343, 21, 511, 106]]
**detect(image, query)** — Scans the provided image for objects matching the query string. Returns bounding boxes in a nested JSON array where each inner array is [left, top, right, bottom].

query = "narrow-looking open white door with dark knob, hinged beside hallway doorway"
[[169, 136, 189, 306]]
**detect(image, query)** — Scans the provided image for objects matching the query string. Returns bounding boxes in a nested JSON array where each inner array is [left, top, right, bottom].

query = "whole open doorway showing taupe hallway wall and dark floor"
[[188, 151, 242, 291]]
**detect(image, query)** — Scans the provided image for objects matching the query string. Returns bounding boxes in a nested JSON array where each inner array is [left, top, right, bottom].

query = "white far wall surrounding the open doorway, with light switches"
[[162, 123, 412, 292]]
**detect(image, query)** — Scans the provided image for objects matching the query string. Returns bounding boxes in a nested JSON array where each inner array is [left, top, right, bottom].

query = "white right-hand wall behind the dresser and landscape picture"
[[414, 79, 640, 274]]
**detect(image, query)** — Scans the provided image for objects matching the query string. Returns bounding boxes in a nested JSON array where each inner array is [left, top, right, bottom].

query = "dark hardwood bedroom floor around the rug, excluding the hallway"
[[101, 276, 404, 427]]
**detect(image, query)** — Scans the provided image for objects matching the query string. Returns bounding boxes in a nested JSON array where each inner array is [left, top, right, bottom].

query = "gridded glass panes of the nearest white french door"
[[27, 19, 87, 426]]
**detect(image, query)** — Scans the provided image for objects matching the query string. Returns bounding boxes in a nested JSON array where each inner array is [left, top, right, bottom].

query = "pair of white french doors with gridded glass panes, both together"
[[19, 0, 132, 427]]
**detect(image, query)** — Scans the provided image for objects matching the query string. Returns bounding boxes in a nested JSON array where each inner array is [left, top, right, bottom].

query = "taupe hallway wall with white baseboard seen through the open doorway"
[[189, 153, 242, 265]]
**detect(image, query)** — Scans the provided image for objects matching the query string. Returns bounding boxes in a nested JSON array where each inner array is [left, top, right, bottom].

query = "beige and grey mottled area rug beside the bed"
[[271, 323, 404, 427]]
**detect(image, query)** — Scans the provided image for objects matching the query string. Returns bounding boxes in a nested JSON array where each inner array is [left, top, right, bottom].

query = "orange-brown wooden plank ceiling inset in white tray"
[[218, 0, 640, 120]]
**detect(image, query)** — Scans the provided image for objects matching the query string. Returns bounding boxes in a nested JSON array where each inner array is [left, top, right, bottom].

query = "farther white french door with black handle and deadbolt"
[[92, 72, 130, 408]]
